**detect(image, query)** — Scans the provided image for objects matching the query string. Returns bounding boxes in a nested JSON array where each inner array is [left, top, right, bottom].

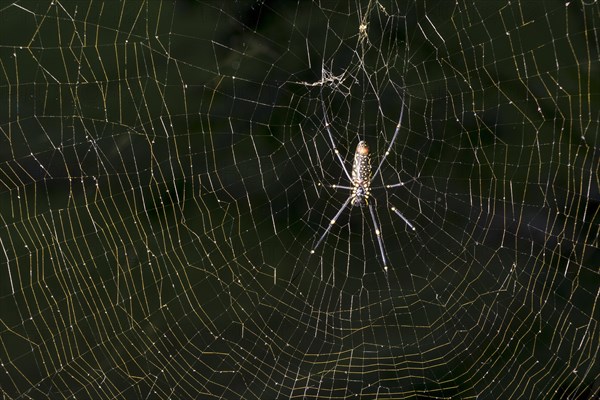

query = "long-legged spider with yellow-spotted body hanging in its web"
[[310, 93, 416, 271]]
